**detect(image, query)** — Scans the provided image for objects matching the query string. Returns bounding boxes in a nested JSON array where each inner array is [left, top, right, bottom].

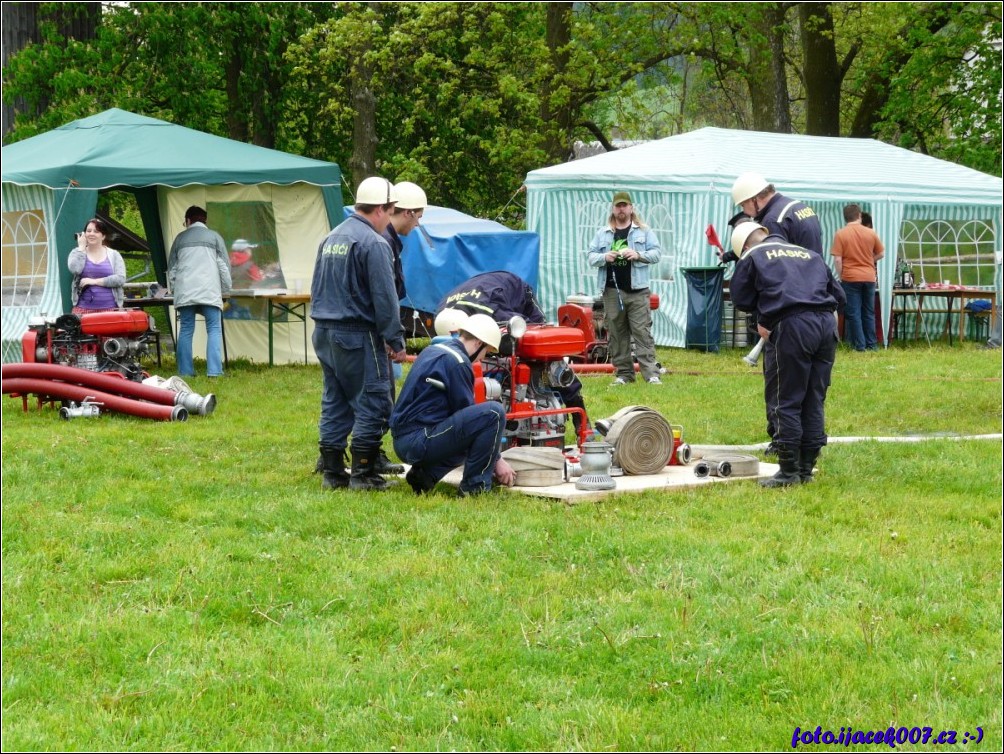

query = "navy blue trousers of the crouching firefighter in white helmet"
[[394, 401, 505, 494]]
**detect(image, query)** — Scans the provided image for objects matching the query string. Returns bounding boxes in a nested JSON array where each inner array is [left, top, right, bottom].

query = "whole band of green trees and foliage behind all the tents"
[[3, 2, 1002, 225]]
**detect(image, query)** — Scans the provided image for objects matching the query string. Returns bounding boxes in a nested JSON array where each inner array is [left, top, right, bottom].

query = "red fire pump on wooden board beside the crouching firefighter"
[[474, 317, 588, 448]]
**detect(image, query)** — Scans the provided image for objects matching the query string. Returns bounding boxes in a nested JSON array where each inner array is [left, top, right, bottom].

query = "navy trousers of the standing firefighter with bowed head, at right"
[[763, 311, 837, 450]]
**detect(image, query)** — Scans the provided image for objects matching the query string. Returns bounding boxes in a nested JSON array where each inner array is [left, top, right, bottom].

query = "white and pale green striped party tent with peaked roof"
[[526, 129, 1004, 347]]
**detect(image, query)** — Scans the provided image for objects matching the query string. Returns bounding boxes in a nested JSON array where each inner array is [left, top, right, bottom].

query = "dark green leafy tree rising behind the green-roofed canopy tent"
[[3, 2, 334, 149]]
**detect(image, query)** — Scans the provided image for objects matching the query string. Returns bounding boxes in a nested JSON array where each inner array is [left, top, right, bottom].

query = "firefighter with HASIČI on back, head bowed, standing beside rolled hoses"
[[729, 222, 845, 487]]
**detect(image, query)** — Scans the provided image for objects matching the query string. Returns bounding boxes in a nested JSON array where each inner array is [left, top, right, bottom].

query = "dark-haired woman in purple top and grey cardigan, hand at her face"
[[66, 218, 126, 314]]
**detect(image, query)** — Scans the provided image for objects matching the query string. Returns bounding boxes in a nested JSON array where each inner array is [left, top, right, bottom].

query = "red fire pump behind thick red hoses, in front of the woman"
[[21, 309, 154, 383]]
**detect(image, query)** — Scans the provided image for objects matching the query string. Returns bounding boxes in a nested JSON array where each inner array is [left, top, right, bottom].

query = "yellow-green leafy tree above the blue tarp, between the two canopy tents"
[[290, 3, 544, 217]]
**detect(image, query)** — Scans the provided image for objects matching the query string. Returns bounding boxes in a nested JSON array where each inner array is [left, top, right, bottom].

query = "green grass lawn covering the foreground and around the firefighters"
[[2, 343, 1002, 751]]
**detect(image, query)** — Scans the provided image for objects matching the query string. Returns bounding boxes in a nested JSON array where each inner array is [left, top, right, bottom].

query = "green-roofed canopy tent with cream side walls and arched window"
[[2, 109, 341, 362]]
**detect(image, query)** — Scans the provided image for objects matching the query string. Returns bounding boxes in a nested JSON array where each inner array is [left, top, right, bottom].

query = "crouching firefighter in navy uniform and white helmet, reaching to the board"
[[391, 314, 516, 495]]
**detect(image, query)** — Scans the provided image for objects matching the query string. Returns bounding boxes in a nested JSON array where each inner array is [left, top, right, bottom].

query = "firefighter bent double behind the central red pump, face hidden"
[[436, 270, 588, 435]]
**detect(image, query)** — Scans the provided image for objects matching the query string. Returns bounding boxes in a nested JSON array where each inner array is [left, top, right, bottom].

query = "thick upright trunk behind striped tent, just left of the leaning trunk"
[[798, 3, 841, 137]]
